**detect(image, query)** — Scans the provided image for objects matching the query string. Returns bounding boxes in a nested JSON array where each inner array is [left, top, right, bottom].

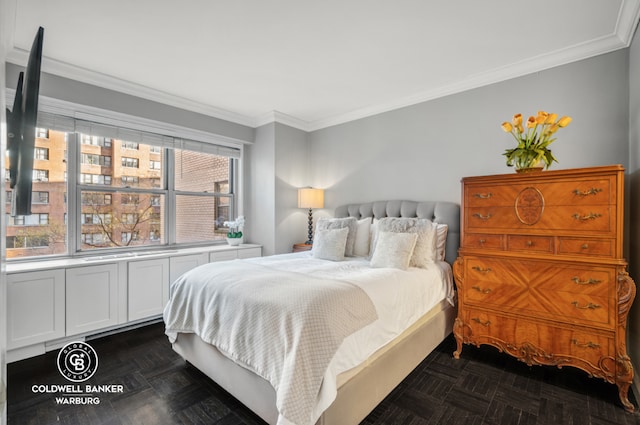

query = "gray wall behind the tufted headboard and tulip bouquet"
[[309, 50, 629, 209]]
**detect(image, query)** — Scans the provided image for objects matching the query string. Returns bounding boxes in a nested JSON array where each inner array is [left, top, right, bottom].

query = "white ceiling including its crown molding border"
[[8, 0, 640, 130]]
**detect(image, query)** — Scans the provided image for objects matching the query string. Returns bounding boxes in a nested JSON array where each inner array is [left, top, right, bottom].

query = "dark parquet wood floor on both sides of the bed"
[[8, 323, 640, 425]]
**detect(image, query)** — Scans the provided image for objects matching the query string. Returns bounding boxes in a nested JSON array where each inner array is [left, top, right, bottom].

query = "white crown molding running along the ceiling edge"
[[6, 0, 640, 132]]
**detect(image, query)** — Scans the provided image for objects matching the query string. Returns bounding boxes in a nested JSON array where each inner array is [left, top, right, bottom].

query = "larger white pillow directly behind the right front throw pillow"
[[372, 217, 437, 268]]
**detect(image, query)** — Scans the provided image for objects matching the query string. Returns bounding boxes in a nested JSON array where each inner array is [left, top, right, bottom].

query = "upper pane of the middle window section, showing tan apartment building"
[[80, 134, 165, 189]]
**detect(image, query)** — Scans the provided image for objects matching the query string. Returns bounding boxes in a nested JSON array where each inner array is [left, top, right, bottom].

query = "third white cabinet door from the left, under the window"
[[127, 258, 169, 320]]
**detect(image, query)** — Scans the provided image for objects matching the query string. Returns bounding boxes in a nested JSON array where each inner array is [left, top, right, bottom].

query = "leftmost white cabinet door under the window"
[[7, 270, 65, 349]]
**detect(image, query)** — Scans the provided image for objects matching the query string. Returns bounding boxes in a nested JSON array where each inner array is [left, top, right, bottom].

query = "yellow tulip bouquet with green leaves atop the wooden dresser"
[[502, 111, 571, 169]]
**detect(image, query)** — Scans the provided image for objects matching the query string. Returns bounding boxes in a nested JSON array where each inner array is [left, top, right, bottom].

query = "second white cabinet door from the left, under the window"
[[66, 264, 118, 336]]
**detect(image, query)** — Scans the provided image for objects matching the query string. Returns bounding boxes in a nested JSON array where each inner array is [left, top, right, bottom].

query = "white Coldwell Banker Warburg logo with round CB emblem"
[[31, 341, 124, 404]]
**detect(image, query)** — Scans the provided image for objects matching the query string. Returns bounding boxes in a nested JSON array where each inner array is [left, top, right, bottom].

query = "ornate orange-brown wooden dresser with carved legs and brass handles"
[[453, 166, 636, 411]]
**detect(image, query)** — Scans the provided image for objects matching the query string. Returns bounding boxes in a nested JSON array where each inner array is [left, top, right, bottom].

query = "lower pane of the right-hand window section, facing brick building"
[[176, 195, 230, 243]]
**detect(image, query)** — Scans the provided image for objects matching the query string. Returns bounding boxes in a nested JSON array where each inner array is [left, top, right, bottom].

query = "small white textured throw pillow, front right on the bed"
[[371, 232, 418, 270]]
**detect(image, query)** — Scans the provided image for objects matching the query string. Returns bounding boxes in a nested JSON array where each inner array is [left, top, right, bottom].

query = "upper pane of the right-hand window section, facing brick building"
[[175, 149, 231, 193]]
